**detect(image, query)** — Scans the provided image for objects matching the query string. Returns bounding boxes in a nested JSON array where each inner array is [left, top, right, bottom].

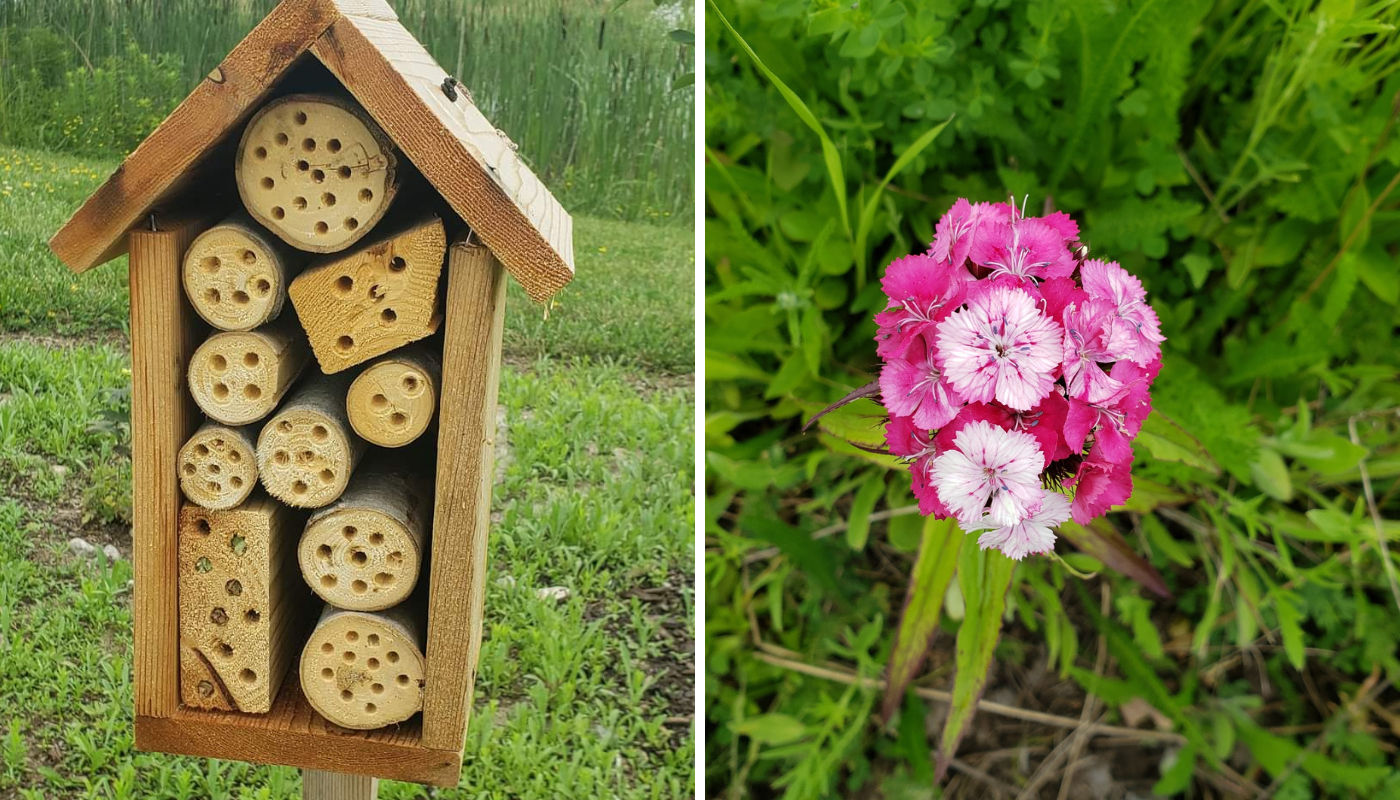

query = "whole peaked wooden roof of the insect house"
[[49, 0, 574, 301]]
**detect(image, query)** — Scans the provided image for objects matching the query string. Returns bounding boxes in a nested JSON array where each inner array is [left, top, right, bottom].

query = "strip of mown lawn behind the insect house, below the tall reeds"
[[0, 146, 694, 373]]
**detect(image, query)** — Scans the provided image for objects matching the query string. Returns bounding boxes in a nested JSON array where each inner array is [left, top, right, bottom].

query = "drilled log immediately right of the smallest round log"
[[258, 375, 365, 509]]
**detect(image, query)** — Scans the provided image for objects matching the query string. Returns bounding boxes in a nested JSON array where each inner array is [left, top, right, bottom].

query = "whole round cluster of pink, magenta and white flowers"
[[875, 200, 1163, 560]]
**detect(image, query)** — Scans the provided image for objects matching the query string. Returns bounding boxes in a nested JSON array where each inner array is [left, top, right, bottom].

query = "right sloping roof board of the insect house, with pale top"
[[311, 17, 574, 301]]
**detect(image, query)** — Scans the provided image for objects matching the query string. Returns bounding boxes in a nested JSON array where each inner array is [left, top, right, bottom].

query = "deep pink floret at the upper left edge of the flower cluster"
[[875, 255, 972, 359]]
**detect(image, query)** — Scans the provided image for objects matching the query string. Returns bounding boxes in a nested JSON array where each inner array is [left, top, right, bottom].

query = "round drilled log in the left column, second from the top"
[[189, 314, 309, 425]]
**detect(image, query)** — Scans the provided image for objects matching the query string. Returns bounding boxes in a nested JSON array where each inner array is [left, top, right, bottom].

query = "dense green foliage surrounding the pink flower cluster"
[[704, 0, 1400, 797]]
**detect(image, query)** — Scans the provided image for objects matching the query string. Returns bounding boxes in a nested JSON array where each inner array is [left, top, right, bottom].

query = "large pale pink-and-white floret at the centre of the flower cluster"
[[937, 286, 1064, 411]]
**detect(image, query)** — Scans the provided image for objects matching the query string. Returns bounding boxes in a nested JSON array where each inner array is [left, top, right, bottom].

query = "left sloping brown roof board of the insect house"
[[49, 0, 347, 272]]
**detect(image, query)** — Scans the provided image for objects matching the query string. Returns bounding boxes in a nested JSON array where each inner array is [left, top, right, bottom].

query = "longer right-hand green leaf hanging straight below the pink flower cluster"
[[937, 546, 1016, 780]]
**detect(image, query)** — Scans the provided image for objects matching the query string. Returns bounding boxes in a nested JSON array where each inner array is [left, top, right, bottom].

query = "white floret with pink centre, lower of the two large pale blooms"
[[932, 420, 1044, 527]]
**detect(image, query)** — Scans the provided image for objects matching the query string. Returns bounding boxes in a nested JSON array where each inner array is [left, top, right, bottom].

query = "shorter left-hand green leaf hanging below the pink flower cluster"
[[883, 517, 966, 722]]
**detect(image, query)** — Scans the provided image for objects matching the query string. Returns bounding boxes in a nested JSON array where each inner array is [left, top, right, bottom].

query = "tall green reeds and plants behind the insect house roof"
[[0, 0, 694, 221]]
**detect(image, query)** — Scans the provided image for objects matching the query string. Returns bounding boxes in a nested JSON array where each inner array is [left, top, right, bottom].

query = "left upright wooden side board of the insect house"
[[131, 212, 213, 717]]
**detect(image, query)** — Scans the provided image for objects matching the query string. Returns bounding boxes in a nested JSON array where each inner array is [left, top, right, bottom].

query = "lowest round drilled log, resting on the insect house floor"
[[301, 604, 423, 730]]
